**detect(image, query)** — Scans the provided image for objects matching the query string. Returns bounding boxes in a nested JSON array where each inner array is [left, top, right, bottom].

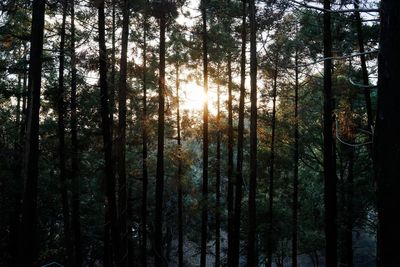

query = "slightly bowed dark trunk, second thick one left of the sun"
[[117, 0, 129, 266]]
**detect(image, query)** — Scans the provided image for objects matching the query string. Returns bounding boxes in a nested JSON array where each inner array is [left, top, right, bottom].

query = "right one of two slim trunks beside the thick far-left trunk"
[[71, 0, 83, 267]]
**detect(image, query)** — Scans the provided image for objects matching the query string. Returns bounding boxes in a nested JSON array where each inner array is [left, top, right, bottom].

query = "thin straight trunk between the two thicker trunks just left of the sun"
[[140, 7, 148, 267]]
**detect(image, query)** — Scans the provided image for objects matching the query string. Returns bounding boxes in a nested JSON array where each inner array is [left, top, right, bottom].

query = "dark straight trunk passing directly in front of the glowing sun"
[[200, 0, 208, 267]]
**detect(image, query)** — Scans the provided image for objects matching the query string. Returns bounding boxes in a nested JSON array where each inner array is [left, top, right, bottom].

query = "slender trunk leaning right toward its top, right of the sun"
[[231, 0, 247, 266]]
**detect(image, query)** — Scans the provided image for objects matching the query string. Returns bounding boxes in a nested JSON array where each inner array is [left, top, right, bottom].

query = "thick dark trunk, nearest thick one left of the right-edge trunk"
[[323, 0, 337, 267]]
